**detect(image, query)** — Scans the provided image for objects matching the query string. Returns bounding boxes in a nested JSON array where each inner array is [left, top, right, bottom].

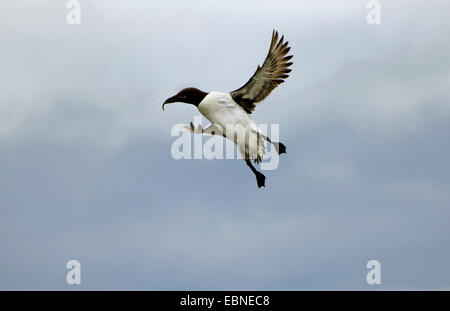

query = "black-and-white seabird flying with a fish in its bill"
[[162, 30, 292, 188]]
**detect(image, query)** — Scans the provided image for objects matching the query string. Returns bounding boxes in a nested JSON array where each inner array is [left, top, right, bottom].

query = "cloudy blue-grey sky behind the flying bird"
[[0, 0, 450, 290]]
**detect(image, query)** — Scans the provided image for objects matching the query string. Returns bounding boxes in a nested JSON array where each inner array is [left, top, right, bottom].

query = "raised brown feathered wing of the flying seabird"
[[230, 30, 292, 113]]
